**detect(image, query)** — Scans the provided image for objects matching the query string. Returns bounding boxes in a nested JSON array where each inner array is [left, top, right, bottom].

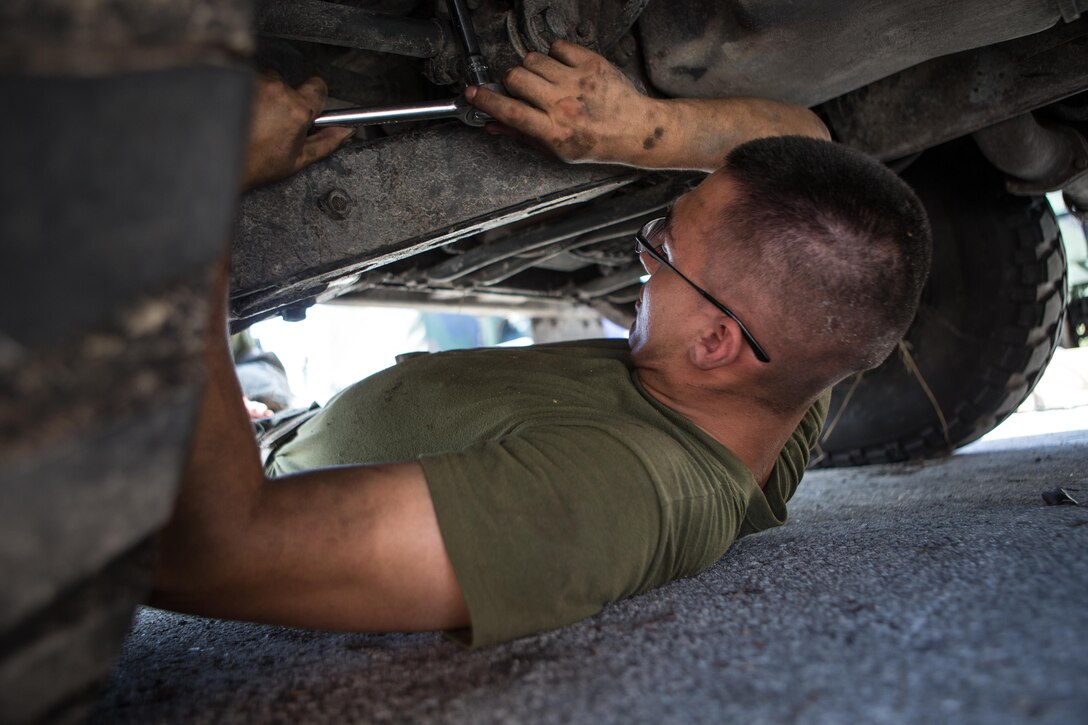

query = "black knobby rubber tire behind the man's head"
[[814, 142, 1067, 467]]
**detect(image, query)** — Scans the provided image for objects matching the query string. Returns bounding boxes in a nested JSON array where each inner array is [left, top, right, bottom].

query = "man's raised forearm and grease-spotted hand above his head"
[[467, 40, 829, 171]]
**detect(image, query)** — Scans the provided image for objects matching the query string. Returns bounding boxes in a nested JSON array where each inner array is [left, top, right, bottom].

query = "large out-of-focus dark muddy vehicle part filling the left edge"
[[0, 7, 250, 723]]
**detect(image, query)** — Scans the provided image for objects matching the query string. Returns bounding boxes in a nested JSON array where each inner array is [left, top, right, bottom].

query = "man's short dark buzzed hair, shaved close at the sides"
[[721, 136, 931, 398]]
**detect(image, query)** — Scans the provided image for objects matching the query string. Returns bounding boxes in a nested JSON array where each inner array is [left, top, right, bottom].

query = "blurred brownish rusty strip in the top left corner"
[[0, 0, 252, 75]]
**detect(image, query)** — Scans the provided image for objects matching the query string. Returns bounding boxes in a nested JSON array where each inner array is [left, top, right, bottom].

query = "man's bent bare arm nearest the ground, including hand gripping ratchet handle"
[[152, 77, 468, 631]]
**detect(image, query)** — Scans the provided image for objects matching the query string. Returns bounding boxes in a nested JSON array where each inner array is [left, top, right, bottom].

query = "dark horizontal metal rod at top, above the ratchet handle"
[[256, 0, 446, 58]]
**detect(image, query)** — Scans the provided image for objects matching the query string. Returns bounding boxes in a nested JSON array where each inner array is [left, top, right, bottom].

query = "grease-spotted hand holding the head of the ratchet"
[[465, 40, 654, 162]]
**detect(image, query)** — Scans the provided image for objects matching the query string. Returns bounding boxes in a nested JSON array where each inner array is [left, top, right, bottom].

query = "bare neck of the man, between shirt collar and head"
[[639, 370, 807, 488]]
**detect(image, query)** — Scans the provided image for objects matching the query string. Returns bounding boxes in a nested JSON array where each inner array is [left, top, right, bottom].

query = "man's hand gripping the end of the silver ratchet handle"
[[242, 73, 355, 189]]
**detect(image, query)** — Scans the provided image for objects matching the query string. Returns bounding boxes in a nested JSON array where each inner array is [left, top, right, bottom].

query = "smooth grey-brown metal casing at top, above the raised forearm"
[[639, 0, 1061, 106]]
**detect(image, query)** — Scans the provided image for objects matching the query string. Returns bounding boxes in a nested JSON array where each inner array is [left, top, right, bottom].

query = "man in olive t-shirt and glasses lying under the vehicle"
[[153, 42, 929, 646]]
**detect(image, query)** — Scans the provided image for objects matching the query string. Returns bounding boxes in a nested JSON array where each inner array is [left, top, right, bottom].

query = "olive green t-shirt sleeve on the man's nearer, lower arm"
[[420, 426, 662, 647]]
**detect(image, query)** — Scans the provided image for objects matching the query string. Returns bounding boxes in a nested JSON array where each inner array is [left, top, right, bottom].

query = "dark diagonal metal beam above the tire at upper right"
[[825, 19, 1088, 159]]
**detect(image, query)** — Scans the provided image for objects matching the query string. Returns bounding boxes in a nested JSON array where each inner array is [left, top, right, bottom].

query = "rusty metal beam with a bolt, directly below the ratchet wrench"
[[232, 124, 639, 319]]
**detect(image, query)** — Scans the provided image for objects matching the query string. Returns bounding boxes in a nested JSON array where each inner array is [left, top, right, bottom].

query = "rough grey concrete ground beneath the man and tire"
[[91, 418, 1088, 723]]
